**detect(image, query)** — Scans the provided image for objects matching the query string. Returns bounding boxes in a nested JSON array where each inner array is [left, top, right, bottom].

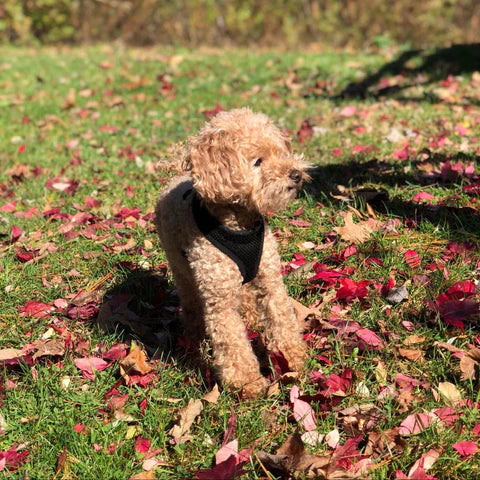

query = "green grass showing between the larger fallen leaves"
[[0, 47, 480, 480]]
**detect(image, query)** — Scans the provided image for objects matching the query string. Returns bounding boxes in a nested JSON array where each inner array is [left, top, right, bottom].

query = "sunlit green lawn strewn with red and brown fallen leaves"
[[0, 46, 480, 480]]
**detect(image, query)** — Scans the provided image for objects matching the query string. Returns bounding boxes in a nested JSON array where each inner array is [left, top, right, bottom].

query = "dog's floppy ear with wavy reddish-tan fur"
[[184, 126, 248, 203]]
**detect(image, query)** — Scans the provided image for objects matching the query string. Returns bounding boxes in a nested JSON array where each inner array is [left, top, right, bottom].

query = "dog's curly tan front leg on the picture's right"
[[254, 230, 307, 370]]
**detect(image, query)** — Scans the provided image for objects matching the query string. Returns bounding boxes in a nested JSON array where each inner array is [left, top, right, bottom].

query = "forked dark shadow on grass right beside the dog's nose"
[[308, 153, 480, 239]]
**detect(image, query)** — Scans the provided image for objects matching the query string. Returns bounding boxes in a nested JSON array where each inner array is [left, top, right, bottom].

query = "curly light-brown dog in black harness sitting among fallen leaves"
[[155, 108, 308, 397]]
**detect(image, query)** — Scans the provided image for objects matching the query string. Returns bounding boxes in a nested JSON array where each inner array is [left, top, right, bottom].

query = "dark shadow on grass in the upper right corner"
[[336, 43, 480, 104]]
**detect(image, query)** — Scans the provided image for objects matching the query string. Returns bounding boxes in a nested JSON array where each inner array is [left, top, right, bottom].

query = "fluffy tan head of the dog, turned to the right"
[[185, 108, 309, 213]]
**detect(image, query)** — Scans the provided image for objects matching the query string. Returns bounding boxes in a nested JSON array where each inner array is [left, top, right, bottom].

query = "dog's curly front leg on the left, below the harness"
[[190, 244, 267, 397]]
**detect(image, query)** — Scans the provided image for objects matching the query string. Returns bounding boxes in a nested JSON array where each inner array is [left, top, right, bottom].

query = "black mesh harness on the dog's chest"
[[184, 189, 265, 283]]
